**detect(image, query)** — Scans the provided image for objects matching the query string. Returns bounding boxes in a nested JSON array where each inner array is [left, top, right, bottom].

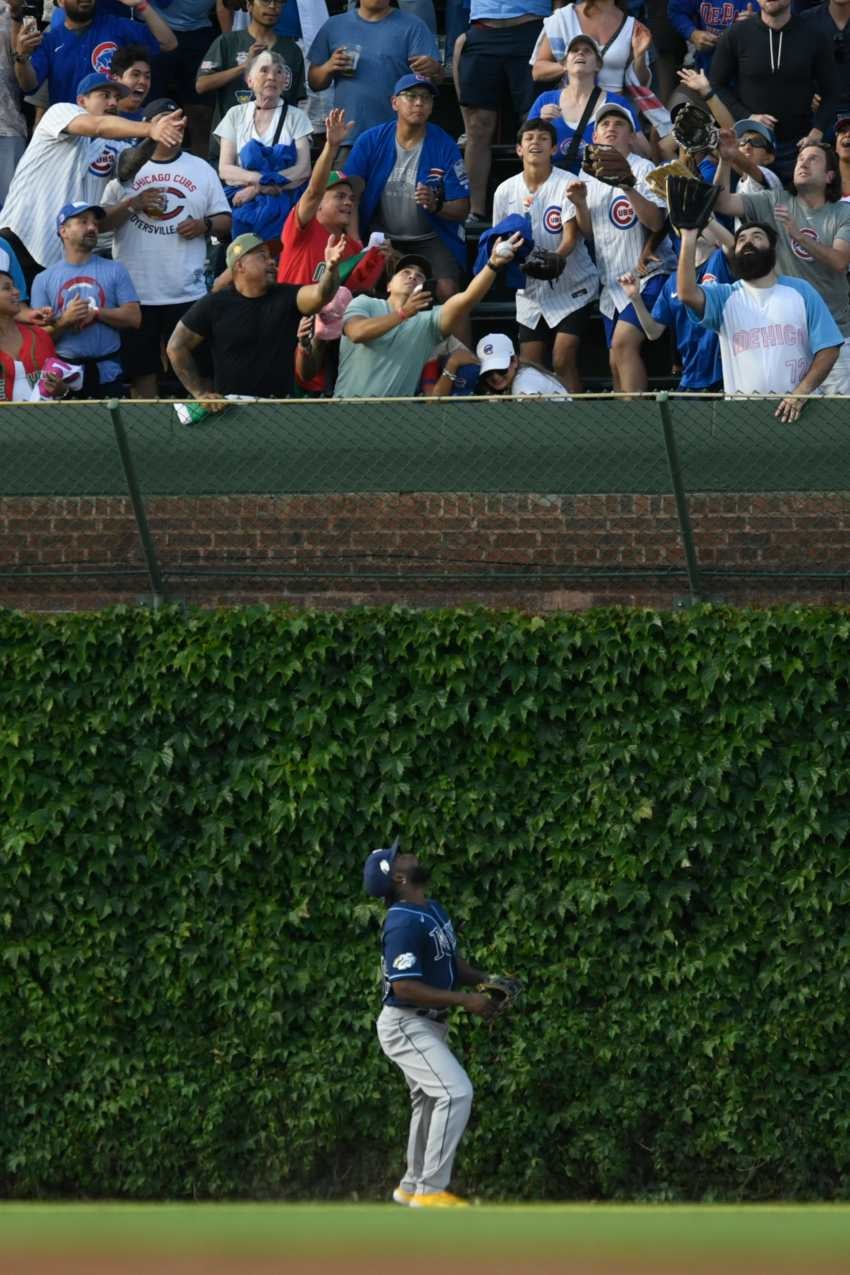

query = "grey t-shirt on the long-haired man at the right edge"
[[740, 190, 850, 337]]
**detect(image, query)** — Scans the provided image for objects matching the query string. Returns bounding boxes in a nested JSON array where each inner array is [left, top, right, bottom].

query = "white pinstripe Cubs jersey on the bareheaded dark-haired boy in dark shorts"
[[493, 168, 599, 328]]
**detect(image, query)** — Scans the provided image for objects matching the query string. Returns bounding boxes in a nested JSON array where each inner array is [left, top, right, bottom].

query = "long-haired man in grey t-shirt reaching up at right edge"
[[716, 129, 850, 394]]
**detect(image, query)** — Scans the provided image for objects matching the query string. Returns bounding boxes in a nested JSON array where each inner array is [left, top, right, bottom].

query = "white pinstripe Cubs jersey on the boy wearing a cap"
[[579, 154, 675, 319]]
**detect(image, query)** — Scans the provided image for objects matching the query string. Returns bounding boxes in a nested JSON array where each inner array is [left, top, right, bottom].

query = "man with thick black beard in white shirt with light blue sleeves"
[[675, 222, 844, 422]]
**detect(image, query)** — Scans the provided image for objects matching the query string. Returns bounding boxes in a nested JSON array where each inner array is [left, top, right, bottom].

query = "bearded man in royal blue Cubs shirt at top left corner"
[[14, 0, 177, 106]]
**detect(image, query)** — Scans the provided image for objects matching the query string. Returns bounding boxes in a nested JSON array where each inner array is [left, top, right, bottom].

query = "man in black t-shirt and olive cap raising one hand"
[[168, 235, 345, 411]]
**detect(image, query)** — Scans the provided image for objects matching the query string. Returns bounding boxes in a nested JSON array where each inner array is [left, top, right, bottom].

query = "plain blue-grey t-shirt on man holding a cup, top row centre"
[[307, 9, 440, 142]]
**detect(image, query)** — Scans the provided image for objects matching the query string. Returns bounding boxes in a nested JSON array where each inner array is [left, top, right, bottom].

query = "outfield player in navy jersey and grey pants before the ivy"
[[363, 840, 494, 1209]]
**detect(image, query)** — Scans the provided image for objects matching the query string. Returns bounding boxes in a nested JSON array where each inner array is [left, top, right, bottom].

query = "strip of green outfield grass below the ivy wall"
[[0, 1204, 850, 1270]]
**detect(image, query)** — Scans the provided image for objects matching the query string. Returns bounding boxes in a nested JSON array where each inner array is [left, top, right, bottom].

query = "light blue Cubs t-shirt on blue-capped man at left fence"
[[32, 254, 139, 385]]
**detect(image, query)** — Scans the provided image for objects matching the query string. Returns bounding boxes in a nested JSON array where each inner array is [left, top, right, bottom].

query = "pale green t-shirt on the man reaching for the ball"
[[335, 297, 443, 398]]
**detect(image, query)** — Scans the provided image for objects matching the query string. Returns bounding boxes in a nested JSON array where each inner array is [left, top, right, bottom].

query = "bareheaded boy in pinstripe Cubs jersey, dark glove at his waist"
[[493, 119, 599, 393]]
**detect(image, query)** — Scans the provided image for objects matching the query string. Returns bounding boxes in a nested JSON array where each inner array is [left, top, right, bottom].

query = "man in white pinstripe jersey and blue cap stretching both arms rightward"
[[0, 73, 185, 283]]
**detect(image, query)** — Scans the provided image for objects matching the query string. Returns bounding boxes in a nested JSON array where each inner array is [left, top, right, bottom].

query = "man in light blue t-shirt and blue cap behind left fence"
[[32, 204, 141, 399]]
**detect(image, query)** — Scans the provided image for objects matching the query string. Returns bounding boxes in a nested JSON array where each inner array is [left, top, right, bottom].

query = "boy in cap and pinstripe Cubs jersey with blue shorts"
[[566, 103, 675, 393]]
